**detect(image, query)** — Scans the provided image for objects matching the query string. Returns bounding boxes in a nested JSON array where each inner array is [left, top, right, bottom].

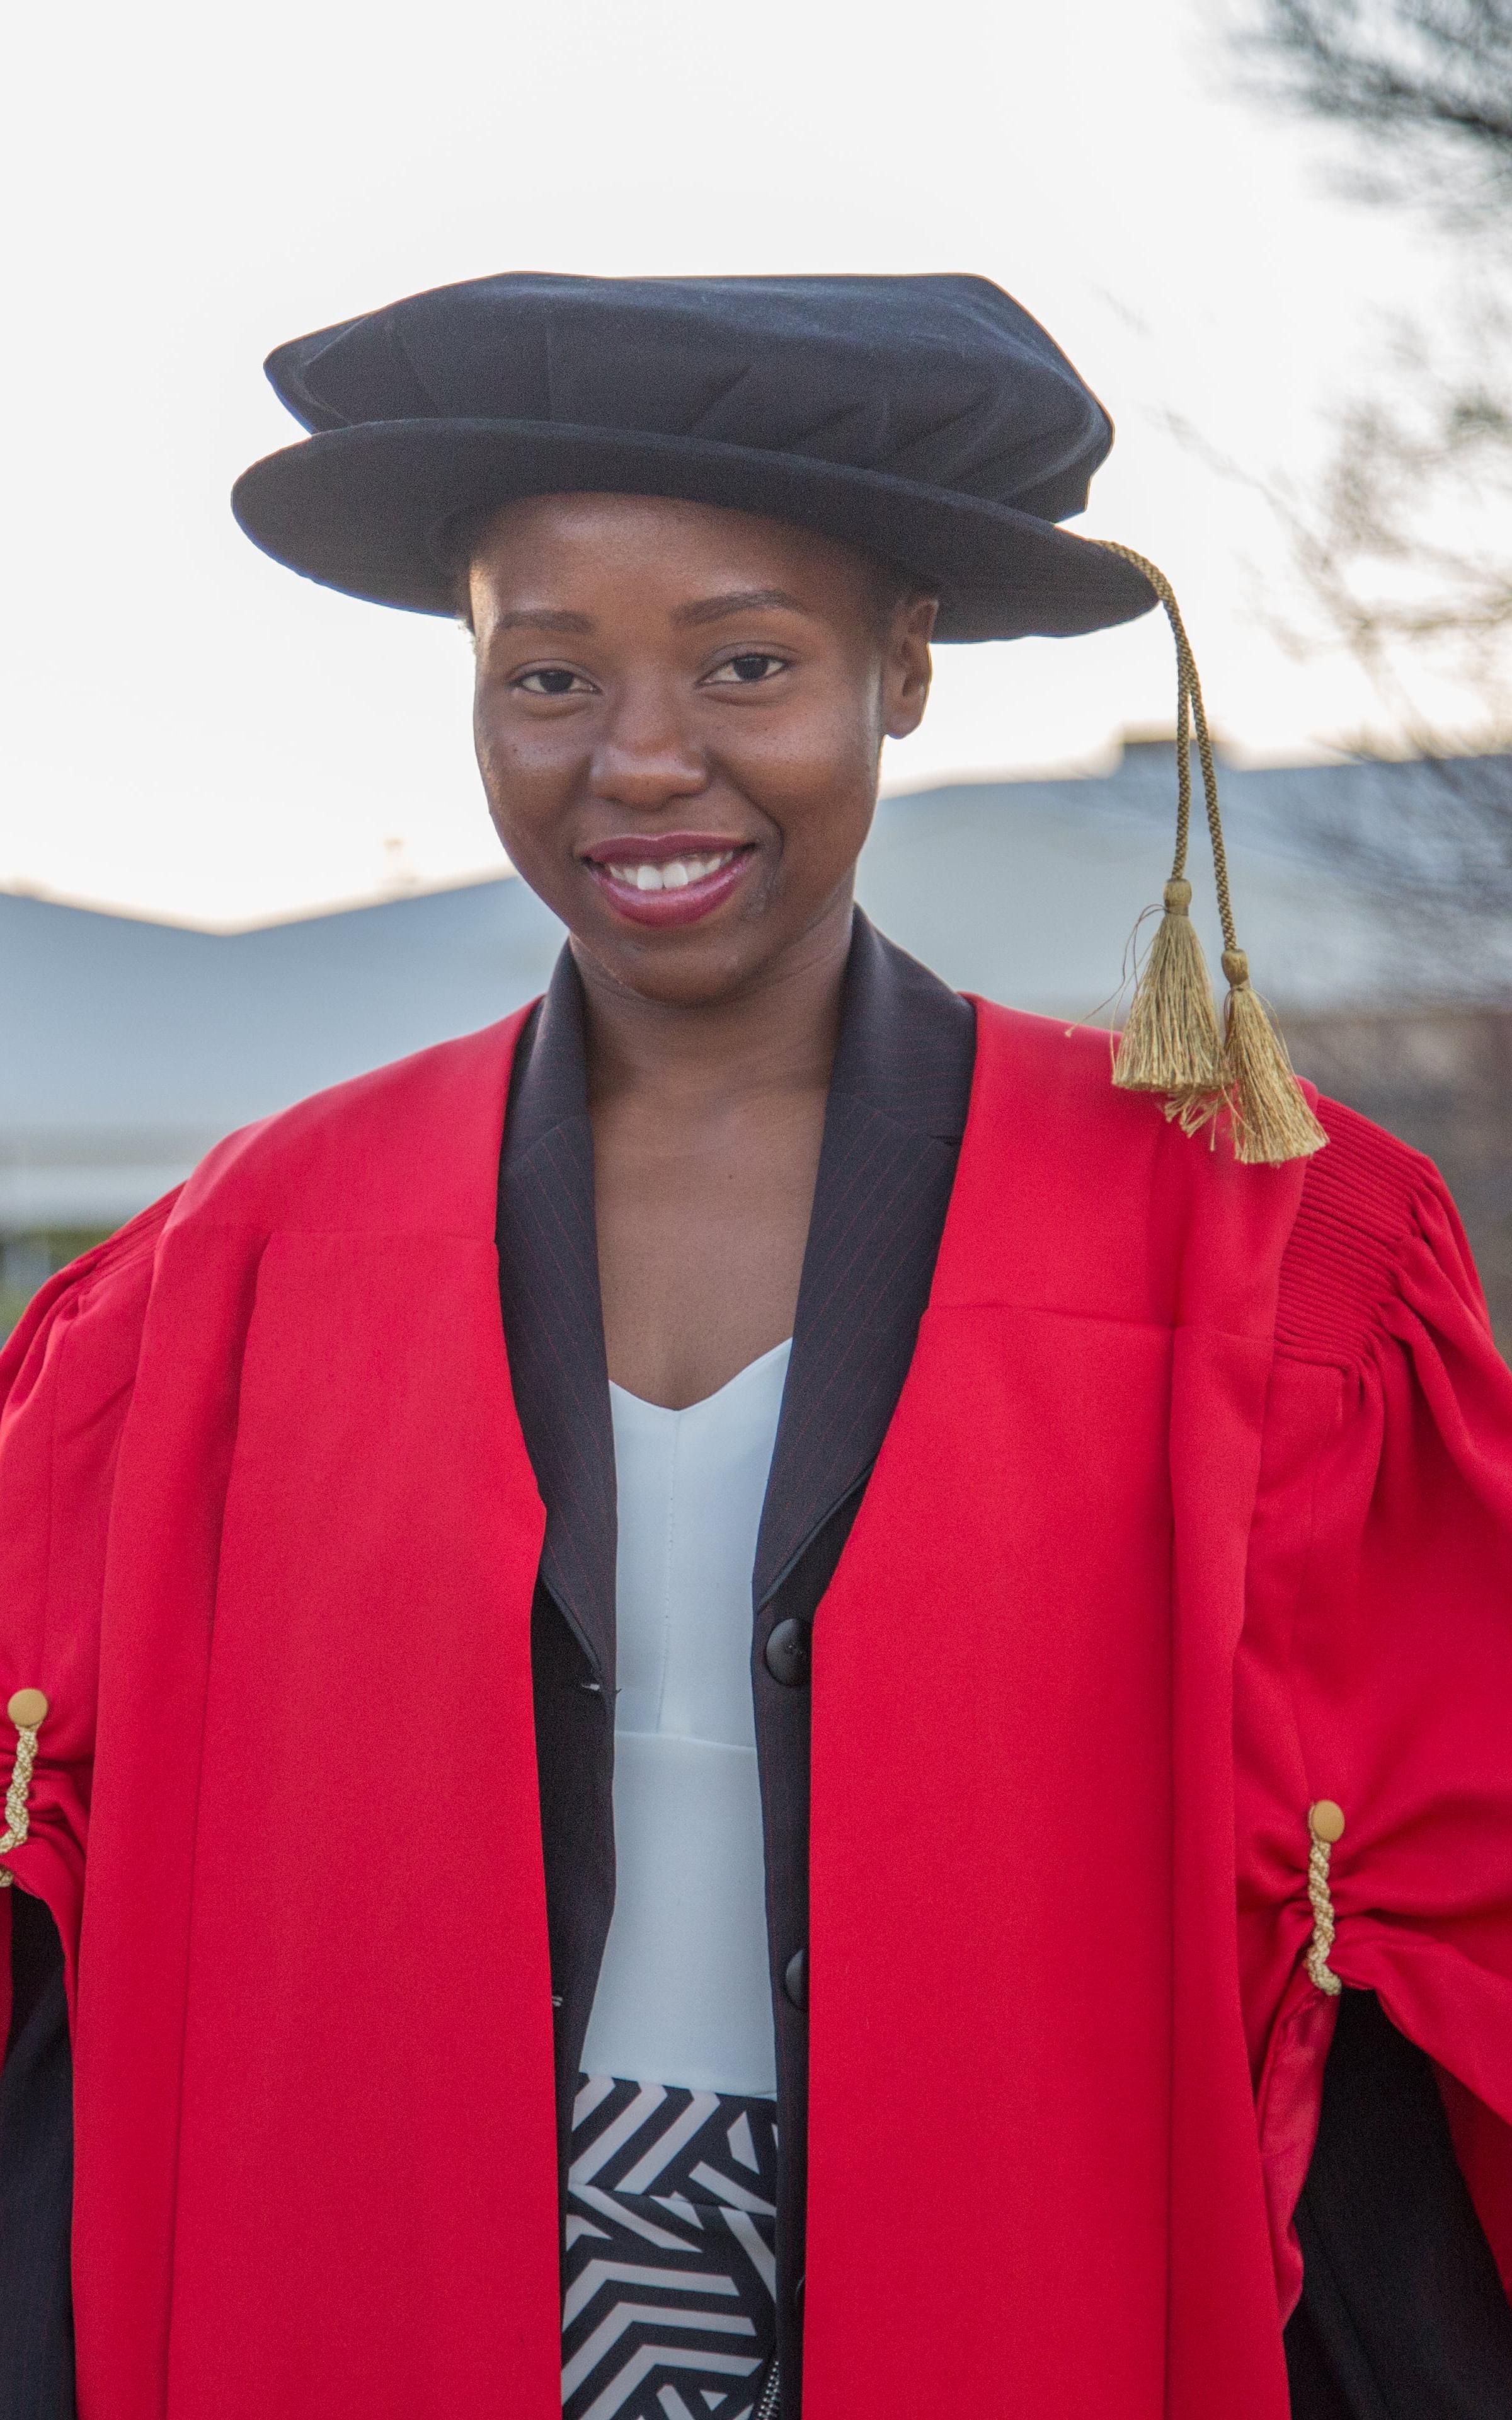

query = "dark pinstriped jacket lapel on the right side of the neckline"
[[755, 910, 977, 1607]]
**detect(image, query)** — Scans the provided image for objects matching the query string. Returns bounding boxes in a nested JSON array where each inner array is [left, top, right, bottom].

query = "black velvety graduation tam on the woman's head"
[[232, 271, 1154, 639]]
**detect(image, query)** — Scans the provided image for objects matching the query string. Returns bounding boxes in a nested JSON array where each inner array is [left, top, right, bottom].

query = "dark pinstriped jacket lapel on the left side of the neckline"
[[498, 948, 617, 1685]]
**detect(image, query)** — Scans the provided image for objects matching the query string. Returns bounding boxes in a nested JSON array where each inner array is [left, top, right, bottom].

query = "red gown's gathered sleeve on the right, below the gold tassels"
[[1236, 1103, 1512, 2308]]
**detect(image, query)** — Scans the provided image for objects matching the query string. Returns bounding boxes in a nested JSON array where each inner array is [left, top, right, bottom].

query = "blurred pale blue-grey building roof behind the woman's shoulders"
[[0, 743, 1499, 1232]]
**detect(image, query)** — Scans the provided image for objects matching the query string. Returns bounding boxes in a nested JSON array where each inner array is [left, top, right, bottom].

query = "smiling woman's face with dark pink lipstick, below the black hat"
[[469, 496, 934, 1005]]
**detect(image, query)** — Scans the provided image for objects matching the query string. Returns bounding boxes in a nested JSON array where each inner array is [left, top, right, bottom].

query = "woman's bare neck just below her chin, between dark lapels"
[[576, 888, 852, 1115]]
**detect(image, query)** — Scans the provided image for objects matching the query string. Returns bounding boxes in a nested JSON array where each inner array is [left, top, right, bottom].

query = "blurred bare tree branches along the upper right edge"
[[1219, 0, 1512, 990]]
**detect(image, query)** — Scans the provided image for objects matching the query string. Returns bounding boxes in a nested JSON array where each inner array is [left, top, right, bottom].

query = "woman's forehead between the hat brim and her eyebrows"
[[469, 493, 876, 613]]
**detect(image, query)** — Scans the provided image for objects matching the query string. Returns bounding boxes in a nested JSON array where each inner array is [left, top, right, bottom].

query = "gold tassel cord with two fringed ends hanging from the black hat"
[[1103, 539, 1328, 1164]]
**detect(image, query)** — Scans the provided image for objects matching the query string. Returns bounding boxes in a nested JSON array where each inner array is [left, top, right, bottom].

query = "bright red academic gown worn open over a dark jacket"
[[0, 1006, 1512, 2420]]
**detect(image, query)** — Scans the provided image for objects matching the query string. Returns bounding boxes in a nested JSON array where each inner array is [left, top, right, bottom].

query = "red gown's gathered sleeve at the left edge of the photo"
[[0, 1198, 172, 2045]]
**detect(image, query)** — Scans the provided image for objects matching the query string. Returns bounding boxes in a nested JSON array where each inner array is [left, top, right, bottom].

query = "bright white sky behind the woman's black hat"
[[0, 0, 1470, 927]]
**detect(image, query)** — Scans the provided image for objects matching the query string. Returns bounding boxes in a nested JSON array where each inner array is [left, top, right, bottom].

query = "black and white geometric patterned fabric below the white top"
[[561, 2077, 777, 2420]]
